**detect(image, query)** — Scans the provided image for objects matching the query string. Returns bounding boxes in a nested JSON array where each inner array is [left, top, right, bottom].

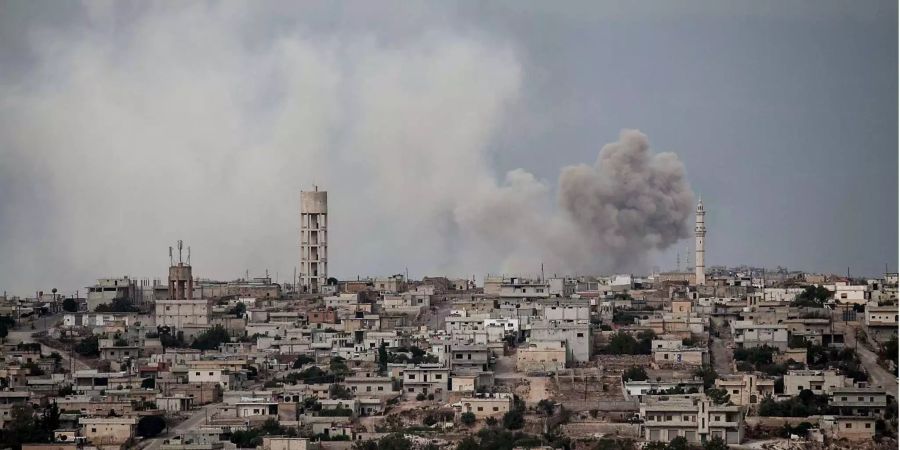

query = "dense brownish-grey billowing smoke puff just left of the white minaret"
[[559, 130, 694, 268]]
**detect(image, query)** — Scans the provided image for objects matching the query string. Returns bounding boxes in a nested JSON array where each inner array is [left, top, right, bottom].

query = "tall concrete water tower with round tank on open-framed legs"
[[300, 186, 328, 293]]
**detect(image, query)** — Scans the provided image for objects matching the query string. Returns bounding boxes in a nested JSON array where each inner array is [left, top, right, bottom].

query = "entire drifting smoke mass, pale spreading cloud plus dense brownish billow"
[[0, 3, 691, 294]]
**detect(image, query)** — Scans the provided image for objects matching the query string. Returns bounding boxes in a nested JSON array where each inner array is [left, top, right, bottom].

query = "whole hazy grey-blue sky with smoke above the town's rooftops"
[[0, 0, 898, 294]]
